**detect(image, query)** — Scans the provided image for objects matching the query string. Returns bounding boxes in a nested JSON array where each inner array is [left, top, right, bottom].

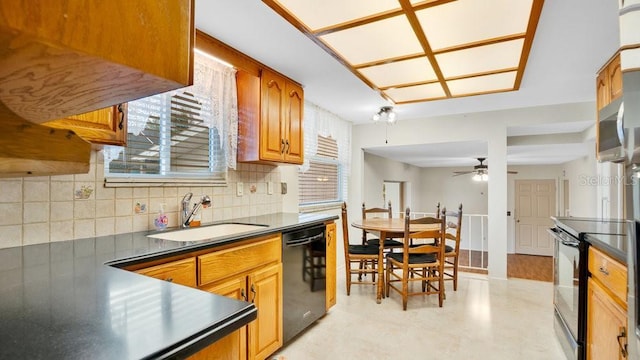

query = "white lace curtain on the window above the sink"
[[127, 51, 238, 169]]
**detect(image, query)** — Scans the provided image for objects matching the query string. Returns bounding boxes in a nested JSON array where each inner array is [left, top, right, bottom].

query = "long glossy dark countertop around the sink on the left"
[[0, 213, 337, 359]]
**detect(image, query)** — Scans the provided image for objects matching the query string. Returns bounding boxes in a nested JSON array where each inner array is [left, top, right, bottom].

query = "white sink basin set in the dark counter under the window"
[[147, 223, 267, 241]]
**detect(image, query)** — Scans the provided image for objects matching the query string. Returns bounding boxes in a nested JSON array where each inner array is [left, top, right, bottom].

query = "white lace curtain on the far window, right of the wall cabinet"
[[300, 101, 352, 198]]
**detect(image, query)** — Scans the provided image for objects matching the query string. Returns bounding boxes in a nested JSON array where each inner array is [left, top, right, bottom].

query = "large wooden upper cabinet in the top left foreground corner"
[[0, 0, 195, 124]]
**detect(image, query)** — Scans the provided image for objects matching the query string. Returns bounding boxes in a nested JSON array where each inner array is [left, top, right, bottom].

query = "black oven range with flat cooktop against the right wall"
[[550, 217, 627, 360]]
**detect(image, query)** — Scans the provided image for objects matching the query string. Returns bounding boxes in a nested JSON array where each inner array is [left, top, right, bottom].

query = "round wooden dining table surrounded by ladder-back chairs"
[[351, 218, 440, 304]]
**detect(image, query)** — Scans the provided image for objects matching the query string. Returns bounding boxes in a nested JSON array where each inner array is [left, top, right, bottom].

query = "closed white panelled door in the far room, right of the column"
[[515, 180, 556, 256]]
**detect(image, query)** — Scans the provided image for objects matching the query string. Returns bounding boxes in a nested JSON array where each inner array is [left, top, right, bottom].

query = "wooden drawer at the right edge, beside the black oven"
[[589, 247, 627, 303]]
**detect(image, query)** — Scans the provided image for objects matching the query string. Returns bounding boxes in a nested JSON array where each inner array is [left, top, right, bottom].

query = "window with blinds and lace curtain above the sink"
[[105, 52, 237, 186]]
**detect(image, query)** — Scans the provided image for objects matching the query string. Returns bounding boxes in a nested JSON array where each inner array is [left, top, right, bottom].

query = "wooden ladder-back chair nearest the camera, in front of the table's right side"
[[385, 208, 446, 310]]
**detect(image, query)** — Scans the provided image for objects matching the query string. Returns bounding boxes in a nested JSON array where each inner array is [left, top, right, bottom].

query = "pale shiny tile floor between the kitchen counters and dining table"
[[272, 273, 565, 360]]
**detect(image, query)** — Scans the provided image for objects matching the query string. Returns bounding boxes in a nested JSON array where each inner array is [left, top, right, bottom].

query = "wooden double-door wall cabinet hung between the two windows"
[[237, 69, 304, 164]]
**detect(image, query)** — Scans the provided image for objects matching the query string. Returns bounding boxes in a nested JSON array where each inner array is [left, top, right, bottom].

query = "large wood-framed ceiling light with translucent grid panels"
[[263, 0, 544, 104]]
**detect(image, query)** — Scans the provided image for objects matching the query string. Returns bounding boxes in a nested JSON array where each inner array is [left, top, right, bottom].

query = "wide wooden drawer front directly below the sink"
[[198, 235, 282, 286]]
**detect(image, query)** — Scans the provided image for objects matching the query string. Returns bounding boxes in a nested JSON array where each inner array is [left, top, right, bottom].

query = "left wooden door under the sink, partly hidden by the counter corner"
[[198, 276, 248, 360]]
